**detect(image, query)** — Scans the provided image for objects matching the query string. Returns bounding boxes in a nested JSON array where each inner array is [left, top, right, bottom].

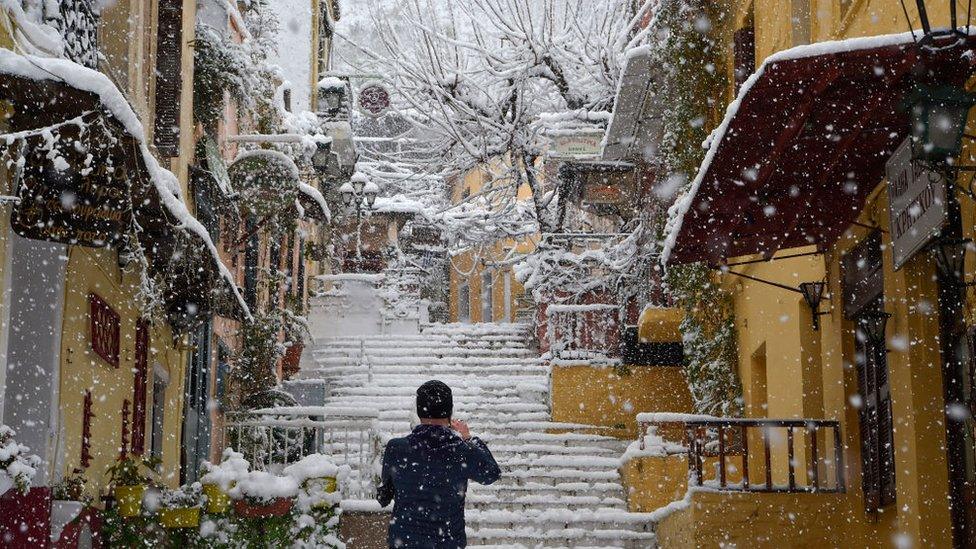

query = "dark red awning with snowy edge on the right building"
[[663, 33, 976, 263]]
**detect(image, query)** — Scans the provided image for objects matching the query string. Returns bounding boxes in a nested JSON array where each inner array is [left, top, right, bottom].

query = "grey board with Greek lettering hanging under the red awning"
[[885, 139, 947, 270]]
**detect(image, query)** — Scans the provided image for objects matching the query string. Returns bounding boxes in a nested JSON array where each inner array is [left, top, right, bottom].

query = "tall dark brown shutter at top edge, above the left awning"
[[153, 0, 183, 157]]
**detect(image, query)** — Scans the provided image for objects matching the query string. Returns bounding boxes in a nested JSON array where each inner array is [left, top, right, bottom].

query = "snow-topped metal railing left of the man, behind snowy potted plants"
[[221, 406, 382, 499]]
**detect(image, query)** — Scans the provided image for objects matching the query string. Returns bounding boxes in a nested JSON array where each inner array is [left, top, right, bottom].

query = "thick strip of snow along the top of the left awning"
[[0, 48, 251, 319]]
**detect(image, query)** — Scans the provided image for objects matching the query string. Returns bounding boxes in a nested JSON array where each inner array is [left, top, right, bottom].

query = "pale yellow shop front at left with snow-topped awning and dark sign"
[[0, 50, 249, 546]]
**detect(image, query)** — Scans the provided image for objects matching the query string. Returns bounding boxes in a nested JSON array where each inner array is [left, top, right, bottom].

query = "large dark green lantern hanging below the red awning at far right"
[[908, 85, 976, 165]]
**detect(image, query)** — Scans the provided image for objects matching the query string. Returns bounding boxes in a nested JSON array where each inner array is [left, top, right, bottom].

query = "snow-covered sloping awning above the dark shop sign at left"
[[0, 48, 250, 327]]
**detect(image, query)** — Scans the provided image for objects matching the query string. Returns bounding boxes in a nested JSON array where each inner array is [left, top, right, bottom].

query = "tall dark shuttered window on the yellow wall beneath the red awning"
[[843, 232, 895, 513]]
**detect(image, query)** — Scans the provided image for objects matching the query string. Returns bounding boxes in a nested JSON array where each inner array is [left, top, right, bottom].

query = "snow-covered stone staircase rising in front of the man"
[[301, 324, 655, 548]]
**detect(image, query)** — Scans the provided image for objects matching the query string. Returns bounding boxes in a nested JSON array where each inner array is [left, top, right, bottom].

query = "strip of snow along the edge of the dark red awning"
[[661, 31, 936, 265]]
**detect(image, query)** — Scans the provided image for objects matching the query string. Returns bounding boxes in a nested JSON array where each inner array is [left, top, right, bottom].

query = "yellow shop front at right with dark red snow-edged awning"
[[659, 33, 976, 547]]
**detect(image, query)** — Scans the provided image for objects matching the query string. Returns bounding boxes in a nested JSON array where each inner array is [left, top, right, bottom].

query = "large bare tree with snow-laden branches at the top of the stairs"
[[344, 0, 655, 243]]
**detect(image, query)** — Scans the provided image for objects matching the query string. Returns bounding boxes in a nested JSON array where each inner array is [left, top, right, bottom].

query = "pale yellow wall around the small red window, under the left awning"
[[60, 246, 187, 494]]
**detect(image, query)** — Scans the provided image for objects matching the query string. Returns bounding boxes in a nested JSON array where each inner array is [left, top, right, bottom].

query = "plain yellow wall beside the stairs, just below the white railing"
[[550, 364, 692, 439]]
